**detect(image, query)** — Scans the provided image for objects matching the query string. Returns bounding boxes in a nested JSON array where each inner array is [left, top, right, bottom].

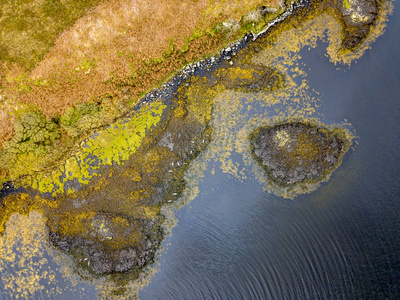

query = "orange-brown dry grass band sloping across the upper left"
[[0, 0, 279, 147]]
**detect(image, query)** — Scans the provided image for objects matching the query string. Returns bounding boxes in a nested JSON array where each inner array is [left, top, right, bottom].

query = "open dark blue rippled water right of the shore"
[[139, 3, 400, 300]]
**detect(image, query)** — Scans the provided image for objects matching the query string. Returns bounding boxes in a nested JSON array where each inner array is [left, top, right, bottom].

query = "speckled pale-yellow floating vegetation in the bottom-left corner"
[[0, 211, 56, 298]]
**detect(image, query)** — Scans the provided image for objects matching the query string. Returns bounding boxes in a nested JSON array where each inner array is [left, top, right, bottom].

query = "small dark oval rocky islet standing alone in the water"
[[250, 121, 350, 187]]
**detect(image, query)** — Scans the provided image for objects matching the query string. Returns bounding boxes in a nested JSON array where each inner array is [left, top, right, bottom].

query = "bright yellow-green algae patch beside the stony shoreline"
[[24, 101, 165, 196]]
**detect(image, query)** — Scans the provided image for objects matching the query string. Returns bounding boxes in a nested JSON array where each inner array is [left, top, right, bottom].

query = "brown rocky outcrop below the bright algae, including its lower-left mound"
[[43, 85, 210, 274]]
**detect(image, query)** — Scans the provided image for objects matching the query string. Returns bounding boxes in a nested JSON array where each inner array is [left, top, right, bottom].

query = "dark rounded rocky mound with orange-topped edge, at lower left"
[[48, 213, 161, 274]]
